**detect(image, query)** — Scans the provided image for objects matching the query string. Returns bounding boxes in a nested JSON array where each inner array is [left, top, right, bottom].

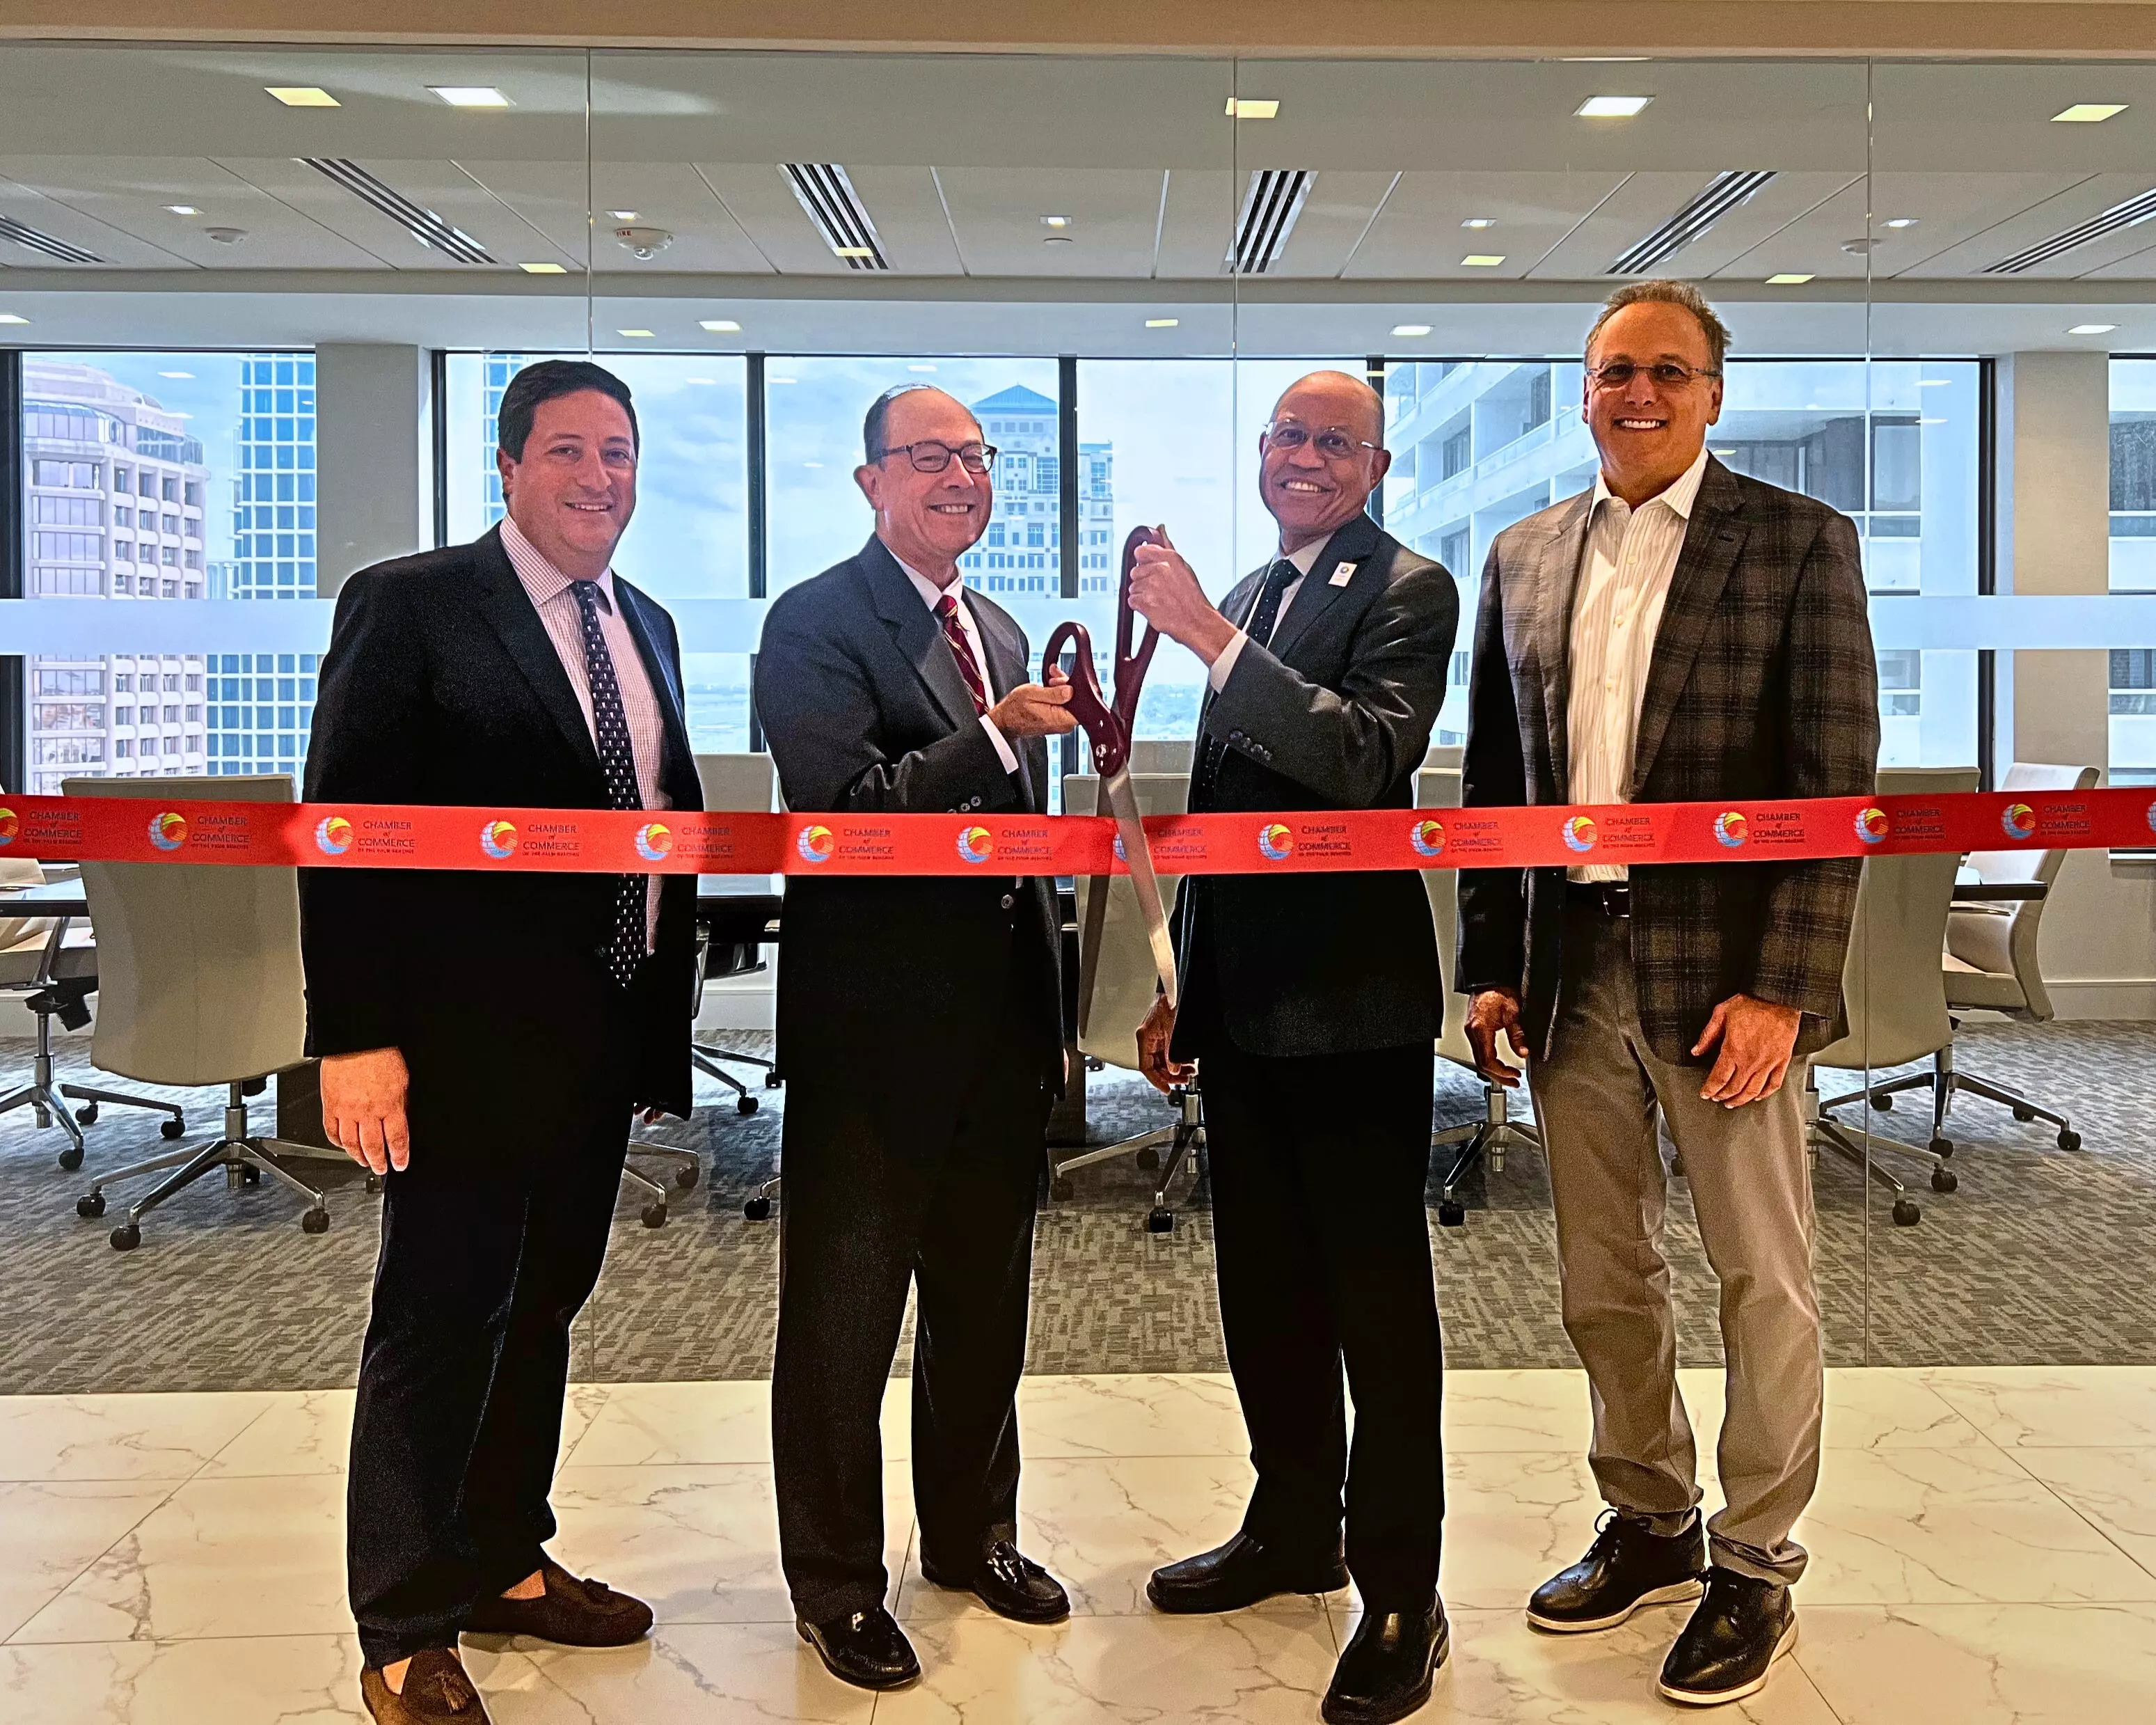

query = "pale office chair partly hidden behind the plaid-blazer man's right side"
[[1811, 768, 1977, 1227]]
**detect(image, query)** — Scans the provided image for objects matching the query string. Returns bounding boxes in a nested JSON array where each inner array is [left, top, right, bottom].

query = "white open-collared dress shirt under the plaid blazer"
[[1565, 448, 1708, 880]]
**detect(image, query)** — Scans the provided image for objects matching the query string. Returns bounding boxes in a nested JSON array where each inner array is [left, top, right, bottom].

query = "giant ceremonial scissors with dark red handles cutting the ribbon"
[[1041, 526, 1175, 1035]]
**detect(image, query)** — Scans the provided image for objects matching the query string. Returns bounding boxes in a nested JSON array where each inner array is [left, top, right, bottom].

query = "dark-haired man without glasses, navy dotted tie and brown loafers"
[[300, 360, 701, 1725]]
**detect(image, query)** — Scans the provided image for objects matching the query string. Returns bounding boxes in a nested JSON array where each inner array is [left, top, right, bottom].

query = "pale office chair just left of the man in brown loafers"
[[63, 774, 347, 1253]]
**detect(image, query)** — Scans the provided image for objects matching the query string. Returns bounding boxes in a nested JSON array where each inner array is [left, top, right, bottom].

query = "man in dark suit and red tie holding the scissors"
[[754, 386, 1072, 1688]]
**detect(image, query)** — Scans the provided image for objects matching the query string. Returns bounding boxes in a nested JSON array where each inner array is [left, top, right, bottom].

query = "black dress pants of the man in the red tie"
[[772, 936, 1050, 1623]]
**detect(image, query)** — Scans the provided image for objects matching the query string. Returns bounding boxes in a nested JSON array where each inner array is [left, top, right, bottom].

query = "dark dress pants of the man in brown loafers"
[[347, 1067, 630, 1667]]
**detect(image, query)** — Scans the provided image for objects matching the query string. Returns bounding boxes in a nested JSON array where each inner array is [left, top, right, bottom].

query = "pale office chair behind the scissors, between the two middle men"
[[1048, 772, 1205, 1234]]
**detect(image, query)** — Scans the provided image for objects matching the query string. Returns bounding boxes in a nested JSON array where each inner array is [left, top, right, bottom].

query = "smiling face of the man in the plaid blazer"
[[1580, 300, 1722, 505]]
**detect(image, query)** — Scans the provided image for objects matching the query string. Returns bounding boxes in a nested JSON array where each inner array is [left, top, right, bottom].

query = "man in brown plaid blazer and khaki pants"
[[1457, 281, 1880, 1706]]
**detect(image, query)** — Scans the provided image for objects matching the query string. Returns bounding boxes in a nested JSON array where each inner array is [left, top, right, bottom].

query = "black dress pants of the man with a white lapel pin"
[[1198, 1033, 1445, 1611]]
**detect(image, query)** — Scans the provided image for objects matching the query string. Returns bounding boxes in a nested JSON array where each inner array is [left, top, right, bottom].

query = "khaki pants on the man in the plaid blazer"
[[1528, 906, 1824, 1583]]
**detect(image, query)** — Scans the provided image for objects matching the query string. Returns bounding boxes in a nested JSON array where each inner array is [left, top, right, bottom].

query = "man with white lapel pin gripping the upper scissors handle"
[[1132, 371, 1459, 1723]]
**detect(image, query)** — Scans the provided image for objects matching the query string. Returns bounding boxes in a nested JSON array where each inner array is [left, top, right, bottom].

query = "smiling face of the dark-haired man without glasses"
[[493, 391, 636, 580]]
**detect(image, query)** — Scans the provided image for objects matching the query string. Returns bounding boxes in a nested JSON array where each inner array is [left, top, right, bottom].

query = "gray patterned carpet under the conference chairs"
[[0, 1024, 2156, 1393]]
